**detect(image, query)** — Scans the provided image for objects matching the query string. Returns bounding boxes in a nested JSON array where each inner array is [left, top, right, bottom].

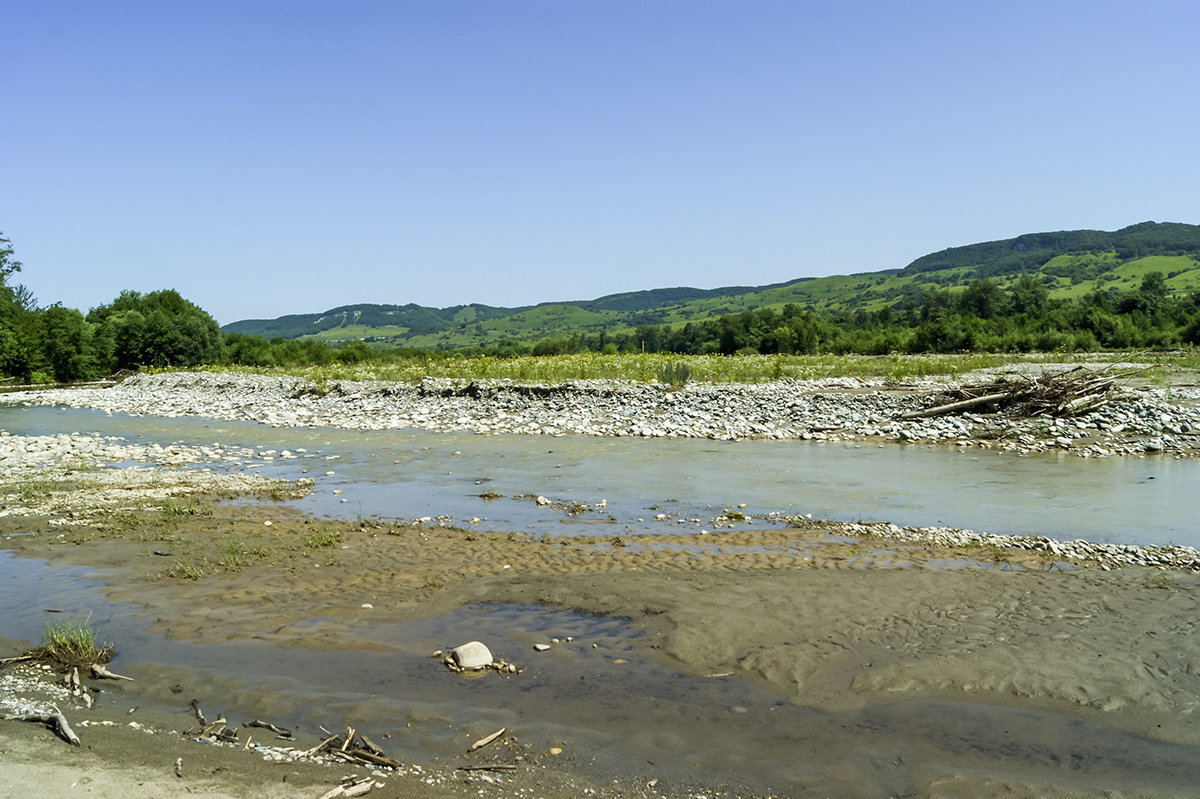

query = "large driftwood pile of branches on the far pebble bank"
[[901, 366, 1148, 419]]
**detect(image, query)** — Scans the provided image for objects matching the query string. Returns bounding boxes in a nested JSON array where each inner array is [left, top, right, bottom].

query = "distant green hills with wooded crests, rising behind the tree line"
[[222, 222, 1200, 348]]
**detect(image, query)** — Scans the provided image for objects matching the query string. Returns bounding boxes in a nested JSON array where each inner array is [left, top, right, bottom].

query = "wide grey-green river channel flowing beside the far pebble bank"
[[0, 400, 1200, 546]]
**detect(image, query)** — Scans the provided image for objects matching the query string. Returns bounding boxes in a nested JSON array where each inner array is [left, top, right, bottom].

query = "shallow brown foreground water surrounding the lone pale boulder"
[[0, 552, 1200, 797]]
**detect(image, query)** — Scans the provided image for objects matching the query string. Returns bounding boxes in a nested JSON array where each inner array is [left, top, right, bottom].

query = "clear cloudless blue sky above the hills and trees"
[[0, 0, 1200, 324]]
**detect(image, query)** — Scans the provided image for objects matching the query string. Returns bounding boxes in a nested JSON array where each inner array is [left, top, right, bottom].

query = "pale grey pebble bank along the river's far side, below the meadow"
[[7, 364, 1200, 457]]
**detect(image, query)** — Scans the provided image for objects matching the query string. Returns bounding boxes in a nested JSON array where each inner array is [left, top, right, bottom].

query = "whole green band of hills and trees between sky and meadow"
[[7, 222, 1200, 383]]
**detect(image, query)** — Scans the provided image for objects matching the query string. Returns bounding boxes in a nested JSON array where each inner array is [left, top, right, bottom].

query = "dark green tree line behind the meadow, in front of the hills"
[[0, 230, 1200, 383]]
